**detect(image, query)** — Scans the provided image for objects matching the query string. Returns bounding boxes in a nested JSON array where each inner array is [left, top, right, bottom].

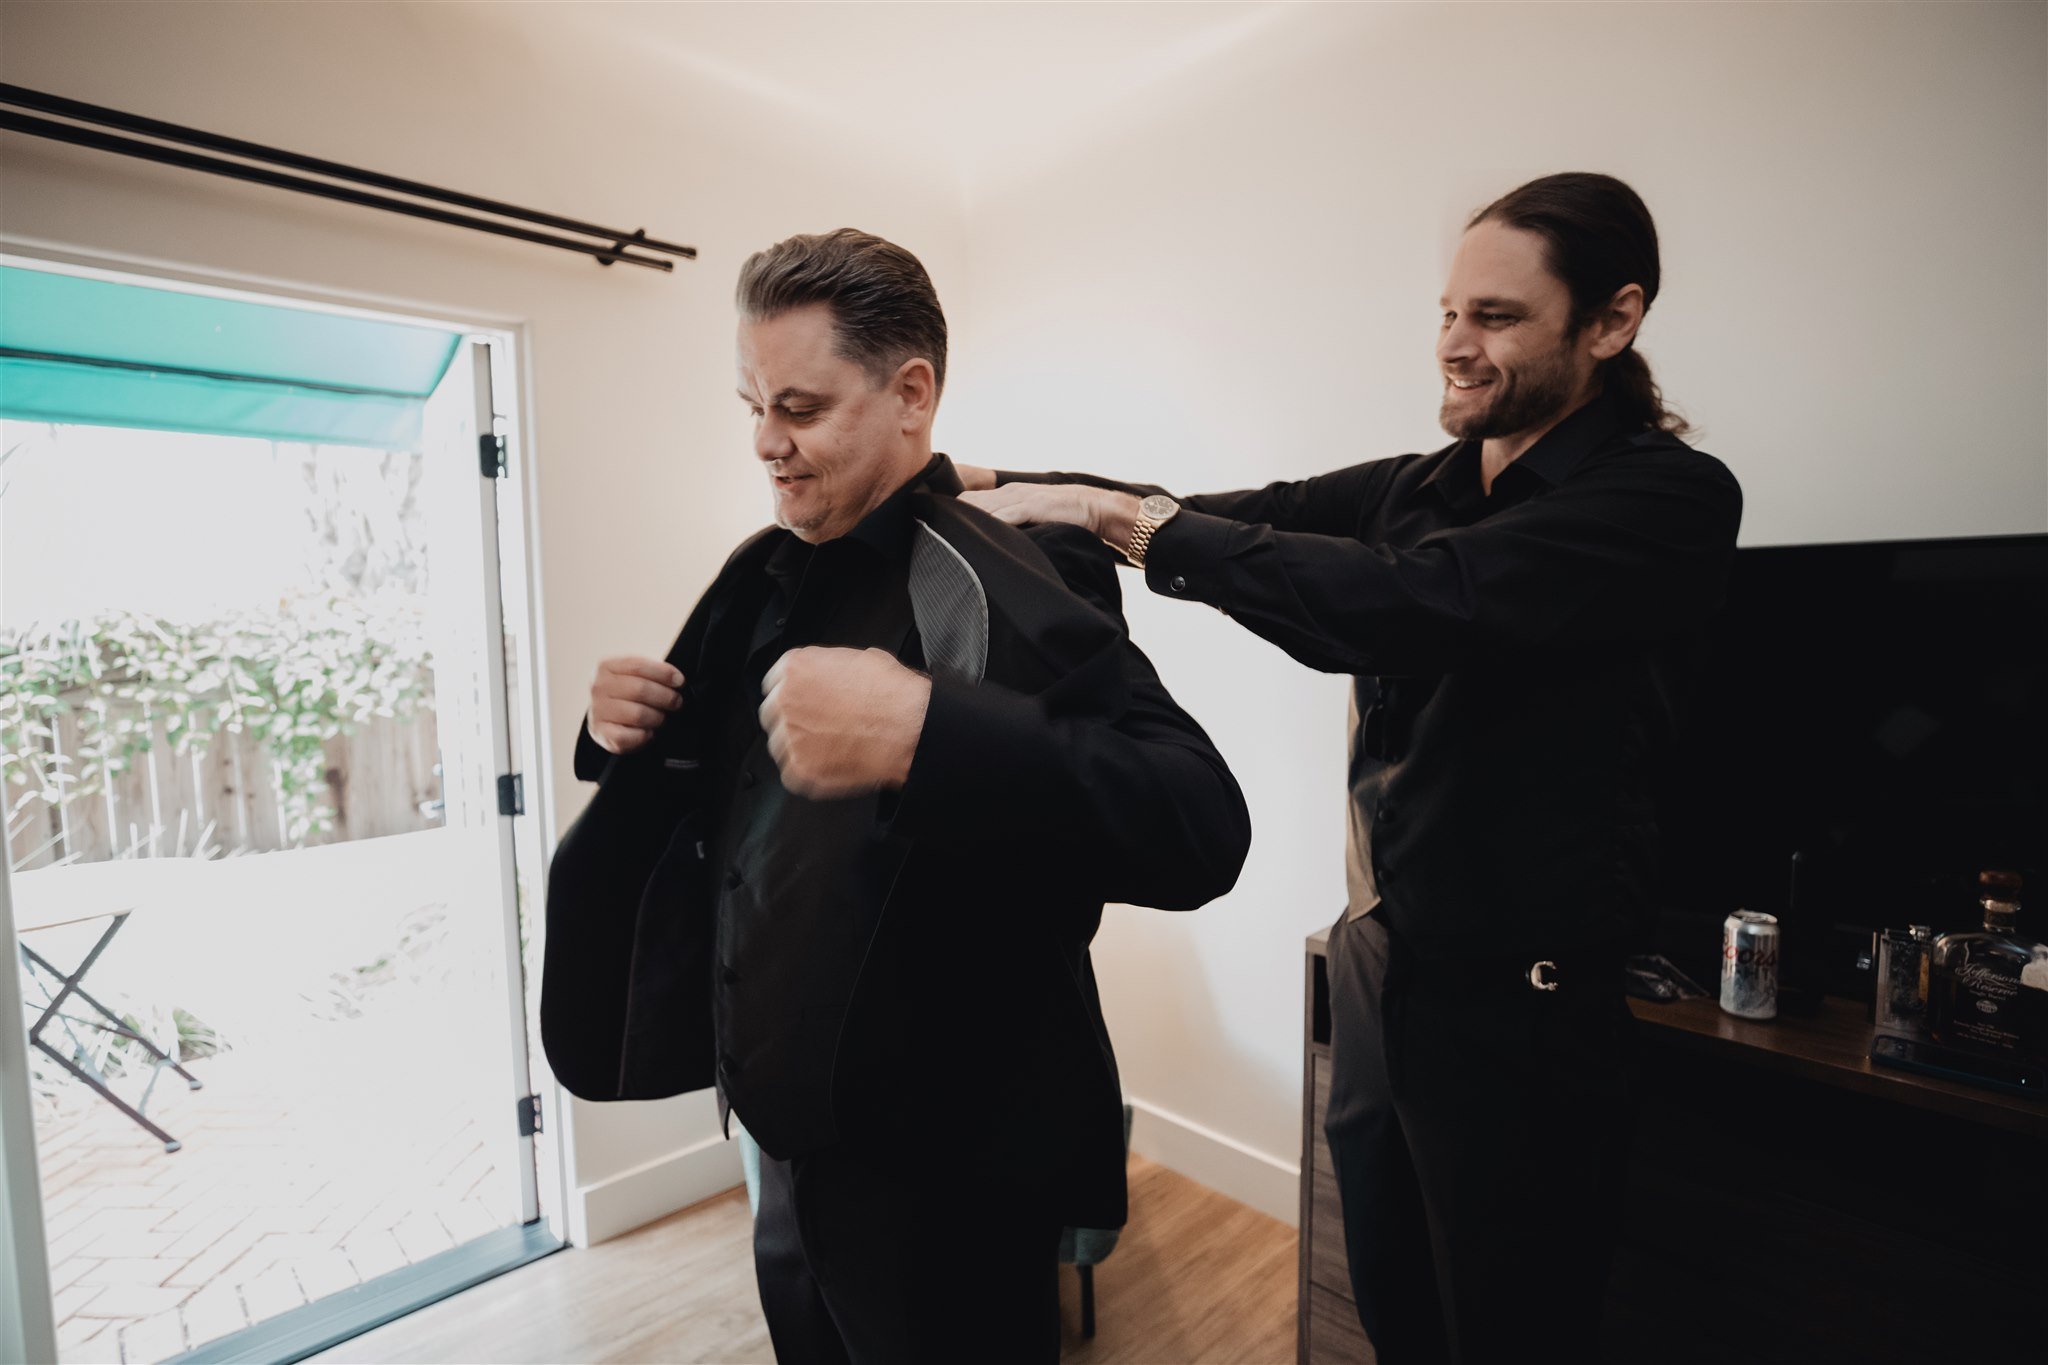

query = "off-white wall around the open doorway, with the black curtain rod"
[[0, 4, 961, 1240]]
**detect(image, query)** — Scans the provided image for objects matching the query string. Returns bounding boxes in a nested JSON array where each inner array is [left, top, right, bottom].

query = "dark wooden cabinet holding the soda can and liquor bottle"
[[1296, 931, 2048, 1365]]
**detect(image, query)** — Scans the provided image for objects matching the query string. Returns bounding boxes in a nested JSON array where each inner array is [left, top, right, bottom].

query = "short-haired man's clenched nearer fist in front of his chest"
[[760, 647, 932, 800]]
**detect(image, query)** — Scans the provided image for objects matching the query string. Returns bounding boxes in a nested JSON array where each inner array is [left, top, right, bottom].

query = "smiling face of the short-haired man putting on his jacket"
[[739, 303, 936, 544]]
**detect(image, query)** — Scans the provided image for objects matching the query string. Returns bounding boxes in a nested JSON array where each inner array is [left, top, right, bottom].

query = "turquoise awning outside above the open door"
[[0, 266, 461, 450]]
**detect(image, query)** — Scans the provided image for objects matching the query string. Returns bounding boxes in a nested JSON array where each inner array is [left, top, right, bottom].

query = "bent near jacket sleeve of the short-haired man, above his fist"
[[895, 526, 1251, 911]]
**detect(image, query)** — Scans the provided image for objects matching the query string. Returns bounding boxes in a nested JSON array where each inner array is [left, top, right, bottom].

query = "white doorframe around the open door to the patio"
[[0, 231, 575, 1326]]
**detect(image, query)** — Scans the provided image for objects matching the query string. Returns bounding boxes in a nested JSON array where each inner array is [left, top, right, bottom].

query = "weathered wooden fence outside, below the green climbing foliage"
[[6, 694, 440, 870]]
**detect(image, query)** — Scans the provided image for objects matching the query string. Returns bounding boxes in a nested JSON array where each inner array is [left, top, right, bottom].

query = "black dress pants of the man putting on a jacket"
[[754, 1146, 1061, 1365]]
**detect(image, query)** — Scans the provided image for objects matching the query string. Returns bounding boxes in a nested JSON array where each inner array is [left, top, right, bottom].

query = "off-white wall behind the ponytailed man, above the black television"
[[948, 4, 2048, 1218]]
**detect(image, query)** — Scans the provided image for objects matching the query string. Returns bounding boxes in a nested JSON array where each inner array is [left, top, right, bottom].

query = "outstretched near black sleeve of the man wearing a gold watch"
[[1145, 446, 1743, 675]]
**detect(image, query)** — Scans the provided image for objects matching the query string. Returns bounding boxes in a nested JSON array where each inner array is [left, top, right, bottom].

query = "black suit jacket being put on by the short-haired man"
[[541, 469, 1251, 1228]]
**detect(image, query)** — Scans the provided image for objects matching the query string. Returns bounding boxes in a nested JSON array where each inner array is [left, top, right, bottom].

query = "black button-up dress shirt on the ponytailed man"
[[999, 388, 1741, 960]]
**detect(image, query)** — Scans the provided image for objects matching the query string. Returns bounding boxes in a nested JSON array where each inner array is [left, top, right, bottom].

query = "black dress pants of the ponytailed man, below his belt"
[[1323, 915, 1634, 1365]]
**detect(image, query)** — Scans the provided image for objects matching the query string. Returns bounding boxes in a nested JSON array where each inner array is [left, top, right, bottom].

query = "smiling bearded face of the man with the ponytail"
[[1436, 221, 1605, 440]]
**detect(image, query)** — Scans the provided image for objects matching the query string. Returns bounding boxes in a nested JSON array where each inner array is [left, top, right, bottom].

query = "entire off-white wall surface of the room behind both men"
[[0, 4, 2048, 1228]]
